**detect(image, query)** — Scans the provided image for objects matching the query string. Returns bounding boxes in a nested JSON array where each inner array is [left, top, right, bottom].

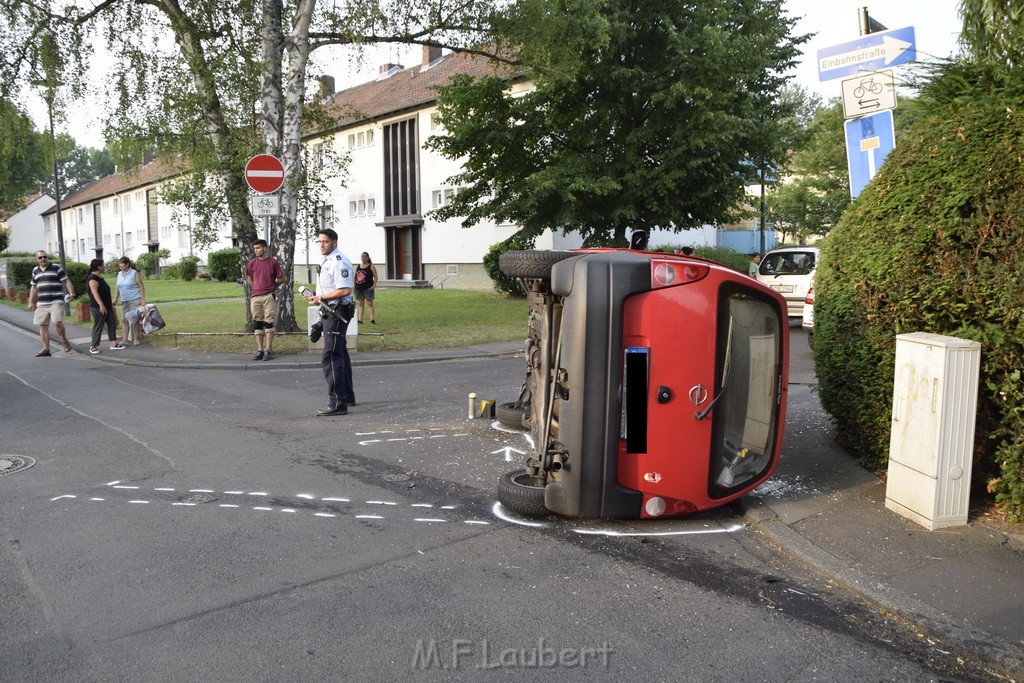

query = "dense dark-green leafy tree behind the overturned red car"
[[428, 0, 805, 244]]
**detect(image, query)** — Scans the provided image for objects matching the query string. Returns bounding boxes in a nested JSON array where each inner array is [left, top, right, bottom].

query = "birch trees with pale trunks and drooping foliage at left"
[[0, 0, 528, 329]]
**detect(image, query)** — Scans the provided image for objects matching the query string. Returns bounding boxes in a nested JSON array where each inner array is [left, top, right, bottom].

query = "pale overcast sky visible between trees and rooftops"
[[31, 0, 961, 147]]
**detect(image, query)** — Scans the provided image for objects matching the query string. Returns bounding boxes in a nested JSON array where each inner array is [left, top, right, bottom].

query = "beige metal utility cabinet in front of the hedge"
[[886, 332, 981, 530]]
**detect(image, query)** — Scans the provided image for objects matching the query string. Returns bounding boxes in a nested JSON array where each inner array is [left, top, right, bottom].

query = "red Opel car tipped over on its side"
[[498, 242, 790, 518]]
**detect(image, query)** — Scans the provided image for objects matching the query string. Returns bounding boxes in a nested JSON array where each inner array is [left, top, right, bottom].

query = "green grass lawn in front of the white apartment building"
[[146, 285, 528, 353]]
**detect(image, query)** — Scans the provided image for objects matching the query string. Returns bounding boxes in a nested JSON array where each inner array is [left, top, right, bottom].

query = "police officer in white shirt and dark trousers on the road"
[[306, 227, 355, 417]]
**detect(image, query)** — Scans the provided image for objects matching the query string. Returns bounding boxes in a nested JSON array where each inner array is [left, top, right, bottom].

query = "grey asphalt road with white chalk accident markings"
[[0, 325, 974, 681]]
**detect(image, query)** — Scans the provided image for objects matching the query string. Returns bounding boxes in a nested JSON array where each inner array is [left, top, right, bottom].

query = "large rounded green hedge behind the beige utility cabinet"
[[814, 62, 1024, 520]]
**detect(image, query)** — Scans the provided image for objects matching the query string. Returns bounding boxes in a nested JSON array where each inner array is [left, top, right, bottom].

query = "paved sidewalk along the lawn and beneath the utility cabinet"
[[0, 304, 1024, 681]]
